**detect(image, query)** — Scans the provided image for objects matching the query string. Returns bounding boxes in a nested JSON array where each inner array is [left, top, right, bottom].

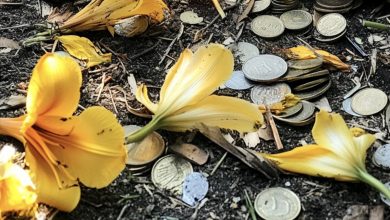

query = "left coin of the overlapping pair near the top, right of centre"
[[251, 15, 284, 38]]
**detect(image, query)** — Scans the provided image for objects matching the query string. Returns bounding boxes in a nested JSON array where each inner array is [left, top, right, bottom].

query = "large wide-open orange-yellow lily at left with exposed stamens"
[[0, 53, 126, 211]]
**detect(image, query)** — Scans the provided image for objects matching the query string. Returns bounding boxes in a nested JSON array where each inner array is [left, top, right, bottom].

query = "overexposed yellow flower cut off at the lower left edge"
[[0, 145, 37, 214]]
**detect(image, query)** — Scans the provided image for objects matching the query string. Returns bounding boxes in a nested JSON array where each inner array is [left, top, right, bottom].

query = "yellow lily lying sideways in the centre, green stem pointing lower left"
[[126, 44, 263, 142]]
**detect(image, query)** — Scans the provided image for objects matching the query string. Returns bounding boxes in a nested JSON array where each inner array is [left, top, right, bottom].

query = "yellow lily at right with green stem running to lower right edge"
[[261, 111, 390, 198]]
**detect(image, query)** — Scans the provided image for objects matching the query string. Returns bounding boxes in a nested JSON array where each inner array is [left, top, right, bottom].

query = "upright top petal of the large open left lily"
[[22, 53, 82, 130]]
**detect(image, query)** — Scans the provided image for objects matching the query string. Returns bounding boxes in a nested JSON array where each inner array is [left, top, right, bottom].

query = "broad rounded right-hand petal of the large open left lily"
[[40, 107, 127, 188]]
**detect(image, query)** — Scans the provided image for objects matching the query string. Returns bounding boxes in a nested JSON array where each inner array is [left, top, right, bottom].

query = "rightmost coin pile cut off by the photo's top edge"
[[314, 0, 363, 13]]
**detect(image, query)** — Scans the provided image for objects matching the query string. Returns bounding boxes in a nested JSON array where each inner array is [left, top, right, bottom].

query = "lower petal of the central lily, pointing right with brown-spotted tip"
[[161, 95, 263, 132]]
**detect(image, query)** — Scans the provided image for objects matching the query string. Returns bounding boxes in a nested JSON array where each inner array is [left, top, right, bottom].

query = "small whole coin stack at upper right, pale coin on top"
[[314, 13, 347, 42]]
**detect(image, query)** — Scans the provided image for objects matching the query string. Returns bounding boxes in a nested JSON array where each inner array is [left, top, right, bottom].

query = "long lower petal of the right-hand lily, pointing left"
[[261, 145, 358, 181]]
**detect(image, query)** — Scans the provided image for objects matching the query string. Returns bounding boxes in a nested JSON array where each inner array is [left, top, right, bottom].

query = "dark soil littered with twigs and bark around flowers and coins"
[[0, 0, 390, 219]]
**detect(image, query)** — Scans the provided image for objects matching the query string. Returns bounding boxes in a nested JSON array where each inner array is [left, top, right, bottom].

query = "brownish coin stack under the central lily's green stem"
[[124, 125, 165, 176]]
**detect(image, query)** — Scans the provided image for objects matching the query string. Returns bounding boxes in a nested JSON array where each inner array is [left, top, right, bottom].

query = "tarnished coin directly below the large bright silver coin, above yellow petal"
[[251, 83, 291, 105]]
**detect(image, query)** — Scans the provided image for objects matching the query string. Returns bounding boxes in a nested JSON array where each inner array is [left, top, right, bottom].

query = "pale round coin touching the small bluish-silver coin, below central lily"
[[152, 155, 193, 194]]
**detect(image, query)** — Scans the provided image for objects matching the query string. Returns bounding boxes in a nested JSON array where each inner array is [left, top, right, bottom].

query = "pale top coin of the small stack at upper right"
[[316, 13, 347, 37]]
